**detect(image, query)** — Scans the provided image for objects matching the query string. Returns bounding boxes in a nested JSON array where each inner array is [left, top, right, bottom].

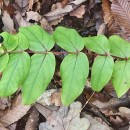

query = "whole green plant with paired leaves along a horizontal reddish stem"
[[0, 25, 130, 105]]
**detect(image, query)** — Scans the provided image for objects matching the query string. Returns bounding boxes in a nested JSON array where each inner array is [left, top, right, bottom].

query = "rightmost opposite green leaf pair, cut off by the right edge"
[[109, 35, 130, 97]]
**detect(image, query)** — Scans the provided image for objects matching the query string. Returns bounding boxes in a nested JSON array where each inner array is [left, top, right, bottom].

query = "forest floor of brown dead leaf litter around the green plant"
[[0, 0, 130, 130]]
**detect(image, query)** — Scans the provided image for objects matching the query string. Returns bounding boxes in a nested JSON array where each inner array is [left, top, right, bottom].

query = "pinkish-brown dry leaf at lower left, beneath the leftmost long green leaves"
[[0, 95, 31, 126]]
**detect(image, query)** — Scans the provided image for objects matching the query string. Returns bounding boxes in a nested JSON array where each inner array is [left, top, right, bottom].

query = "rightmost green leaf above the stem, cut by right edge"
[[109, 35, 130, 58]]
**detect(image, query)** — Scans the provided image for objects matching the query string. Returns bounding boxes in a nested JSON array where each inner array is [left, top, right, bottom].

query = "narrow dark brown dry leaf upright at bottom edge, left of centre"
[[25, 107, 39, 130]]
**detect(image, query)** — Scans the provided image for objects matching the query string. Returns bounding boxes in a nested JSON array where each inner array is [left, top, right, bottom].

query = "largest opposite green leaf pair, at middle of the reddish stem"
[[54, 27, 89, 105]]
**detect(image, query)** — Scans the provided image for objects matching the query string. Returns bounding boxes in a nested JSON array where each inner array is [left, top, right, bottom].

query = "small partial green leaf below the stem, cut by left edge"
[[0, 54, 9, 72]]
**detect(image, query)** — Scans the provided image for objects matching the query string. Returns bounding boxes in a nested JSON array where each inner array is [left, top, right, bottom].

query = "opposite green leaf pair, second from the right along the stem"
[[84, 35, 114, 92]]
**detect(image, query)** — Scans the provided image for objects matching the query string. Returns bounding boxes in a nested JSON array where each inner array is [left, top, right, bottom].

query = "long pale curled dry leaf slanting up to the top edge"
[[44, 0, 86, 21]]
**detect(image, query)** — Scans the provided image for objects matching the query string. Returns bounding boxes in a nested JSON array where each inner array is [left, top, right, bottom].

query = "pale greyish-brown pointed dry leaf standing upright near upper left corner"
[[2, 11, 15, 32]]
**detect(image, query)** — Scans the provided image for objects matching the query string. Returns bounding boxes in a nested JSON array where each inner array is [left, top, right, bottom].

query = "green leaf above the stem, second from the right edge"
[[84, 35, 110, 54]]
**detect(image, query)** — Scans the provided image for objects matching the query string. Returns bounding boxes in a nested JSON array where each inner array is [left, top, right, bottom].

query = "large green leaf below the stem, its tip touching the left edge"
[[0, 52, 30, 97]]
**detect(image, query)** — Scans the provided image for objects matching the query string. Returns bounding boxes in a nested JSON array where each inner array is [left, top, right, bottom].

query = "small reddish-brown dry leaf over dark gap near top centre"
[[70, 5, 85, 18]]
